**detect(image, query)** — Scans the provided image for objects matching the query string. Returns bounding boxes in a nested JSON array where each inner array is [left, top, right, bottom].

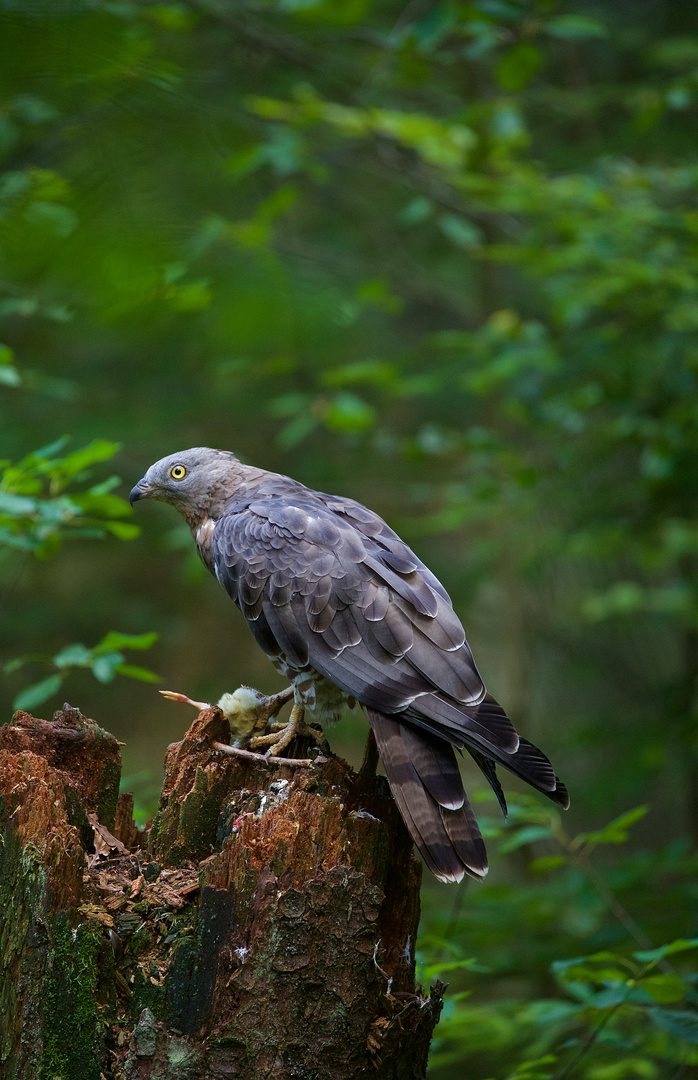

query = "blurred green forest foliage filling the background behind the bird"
[[0, 0, 698, 1080]]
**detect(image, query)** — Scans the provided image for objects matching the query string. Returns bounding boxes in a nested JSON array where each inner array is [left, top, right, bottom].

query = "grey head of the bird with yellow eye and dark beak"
[[129, 446, 240, 523]]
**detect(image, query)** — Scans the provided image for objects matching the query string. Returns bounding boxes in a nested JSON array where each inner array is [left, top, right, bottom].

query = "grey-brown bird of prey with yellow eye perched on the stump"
[[131, 446, 568, 881]]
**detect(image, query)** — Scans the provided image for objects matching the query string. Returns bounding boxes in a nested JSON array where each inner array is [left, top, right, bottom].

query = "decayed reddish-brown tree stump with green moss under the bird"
[[0, 706, 442, 1080]]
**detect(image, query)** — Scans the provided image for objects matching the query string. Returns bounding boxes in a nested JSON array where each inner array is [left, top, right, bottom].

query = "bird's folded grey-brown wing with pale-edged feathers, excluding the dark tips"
[[212, 485, 492, 721]]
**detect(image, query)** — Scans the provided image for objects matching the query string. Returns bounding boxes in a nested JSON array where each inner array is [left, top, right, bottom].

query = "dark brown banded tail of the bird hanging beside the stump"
[[367, 708, 487, 881]]
